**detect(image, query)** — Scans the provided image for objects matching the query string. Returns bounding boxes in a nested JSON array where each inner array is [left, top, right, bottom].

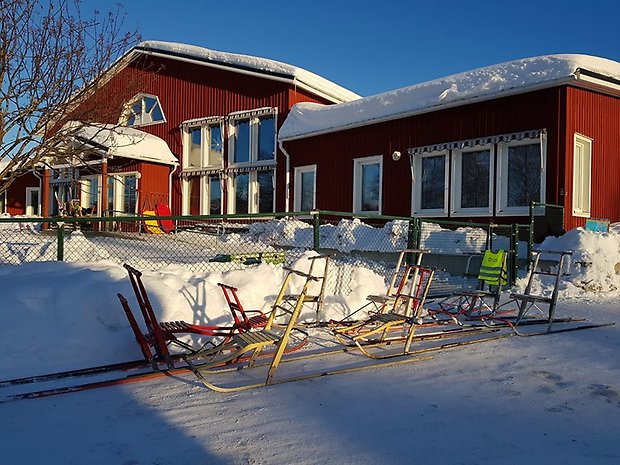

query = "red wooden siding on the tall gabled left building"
[[66, 57, 328, 214]]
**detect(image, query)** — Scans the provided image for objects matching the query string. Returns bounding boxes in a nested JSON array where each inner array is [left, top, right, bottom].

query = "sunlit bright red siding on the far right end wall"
[[564, 87, 620, 229]]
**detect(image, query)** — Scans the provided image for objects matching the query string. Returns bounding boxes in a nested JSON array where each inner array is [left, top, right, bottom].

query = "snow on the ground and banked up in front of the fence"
[[0, 223, 620, 465]]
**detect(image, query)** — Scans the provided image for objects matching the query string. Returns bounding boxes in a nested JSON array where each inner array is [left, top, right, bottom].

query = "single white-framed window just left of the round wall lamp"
[[353, 155, 383, 215]]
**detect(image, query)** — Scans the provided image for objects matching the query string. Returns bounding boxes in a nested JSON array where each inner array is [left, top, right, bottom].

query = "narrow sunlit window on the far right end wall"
[[573, 134, 592, 217]]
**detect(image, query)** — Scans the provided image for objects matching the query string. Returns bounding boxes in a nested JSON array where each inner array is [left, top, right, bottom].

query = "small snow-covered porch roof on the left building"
[[63, 121, 179, 165]]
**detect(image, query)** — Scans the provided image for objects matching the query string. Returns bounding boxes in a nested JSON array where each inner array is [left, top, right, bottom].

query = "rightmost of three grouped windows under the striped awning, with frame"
[[497, 138, 546, 215]]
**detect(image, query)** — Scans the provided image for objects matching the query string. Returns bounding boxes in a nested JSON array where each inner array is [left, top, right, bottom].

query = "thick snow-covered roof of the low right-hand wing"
[[278, 55, 620, 141]]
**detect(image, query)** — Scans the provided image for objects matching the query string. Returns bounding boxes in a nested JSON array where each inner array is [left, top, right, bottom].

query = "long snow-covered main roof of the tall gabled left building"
[[132, 40, 360, 103]]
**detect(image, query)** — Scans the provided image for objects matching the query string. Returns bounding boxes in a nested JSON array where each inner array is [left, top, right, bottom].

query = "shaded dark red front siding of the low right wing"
[[285, 88, 563, 221]]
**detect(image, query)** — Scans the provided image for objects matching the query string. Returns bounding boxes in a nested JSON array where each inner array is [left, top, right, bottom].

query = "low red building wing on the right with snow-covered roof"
[[279, 55, 620, 229]]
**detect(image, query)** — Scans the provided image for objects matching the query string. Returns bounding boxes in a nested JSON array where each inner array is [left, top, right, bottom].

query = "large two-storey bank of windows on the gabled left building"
[[182, 108, 277, 215]]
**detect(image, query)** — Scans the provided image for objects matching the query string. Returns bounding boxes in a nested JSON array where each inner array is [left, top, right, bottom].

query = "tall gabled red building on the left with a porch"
[[7, 42, 359, 216]]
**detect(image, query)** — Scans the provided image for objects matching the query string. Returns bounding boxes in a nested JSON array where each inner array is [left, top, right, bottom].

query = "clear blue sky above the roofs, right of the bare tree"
[[82, 0, 620, 96]]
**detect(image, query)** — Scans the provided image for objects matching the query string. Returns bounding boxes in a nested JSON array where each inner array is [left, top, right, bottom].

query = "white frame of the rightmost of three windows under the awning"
[[495, 136, 547, 216]]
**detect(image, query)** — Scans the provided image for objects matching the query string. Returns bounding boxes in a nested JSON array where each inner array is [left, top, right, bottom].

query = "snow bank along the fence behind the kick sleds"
[[0, 252, 385, 379]]
